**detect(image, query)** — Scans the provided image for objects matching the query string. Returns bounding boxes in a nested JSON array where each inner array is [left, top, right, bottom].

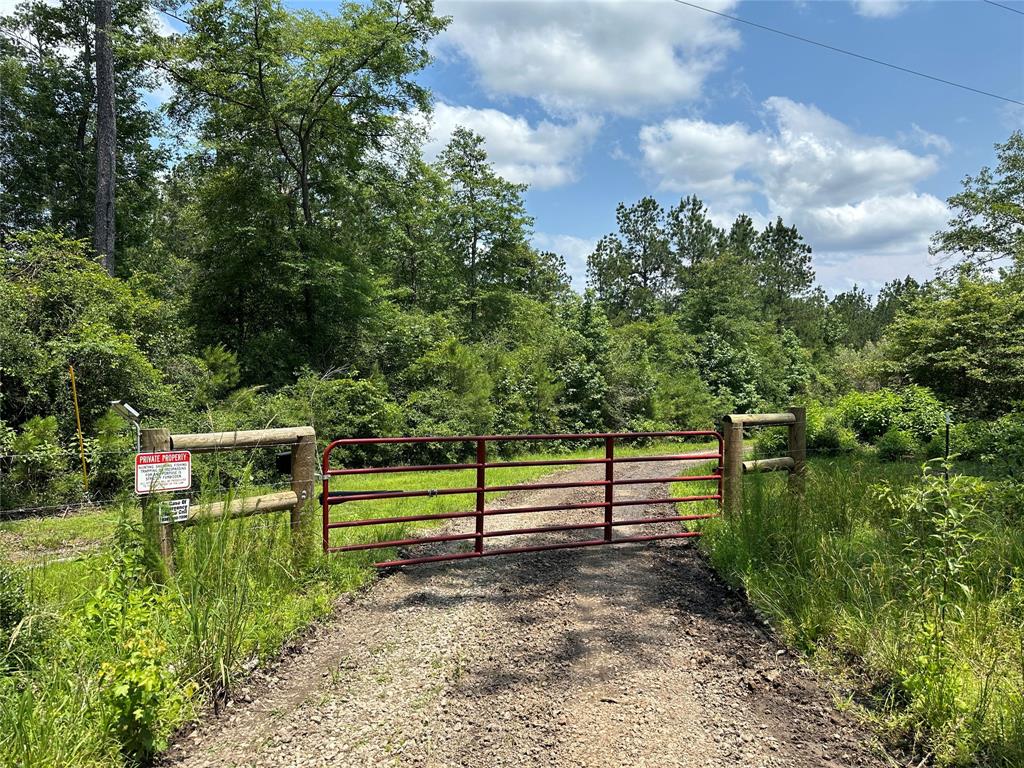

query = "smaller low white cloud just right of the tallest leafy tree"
[[425, 103, 601, 187]]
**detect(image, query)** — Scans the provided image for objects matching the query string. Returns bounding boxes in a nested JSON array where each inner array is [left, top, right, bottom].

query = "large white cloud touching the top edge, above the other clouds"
[[436, 0, 739, 114]]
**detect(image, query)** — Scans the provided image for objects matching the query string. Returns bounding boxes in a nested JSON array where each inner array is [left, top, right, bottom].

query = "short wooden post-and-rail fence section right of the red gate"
[[722, 406, 807, 515]]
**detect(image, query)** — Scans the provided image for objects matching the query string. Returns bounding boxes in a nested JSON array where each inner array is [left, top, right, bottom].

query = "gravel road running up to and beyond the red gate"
[[166, 460, 891, 768]]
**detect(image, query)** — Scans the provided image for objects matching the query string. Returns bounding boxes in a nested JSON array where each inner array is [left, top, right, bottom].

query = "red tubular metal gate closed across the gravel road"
[[321, 430, 724, 566]]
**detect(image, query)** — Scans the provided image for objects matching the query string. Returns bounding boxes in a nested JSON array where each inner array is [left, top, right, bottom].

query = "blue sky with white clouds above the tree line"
[[399, 0, 1024, 292]]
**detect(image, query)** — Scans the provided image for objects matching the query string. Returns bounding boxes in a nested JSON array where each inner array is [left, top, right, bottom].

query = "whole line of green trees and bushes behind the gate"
[[0, 0, 1024, 505]]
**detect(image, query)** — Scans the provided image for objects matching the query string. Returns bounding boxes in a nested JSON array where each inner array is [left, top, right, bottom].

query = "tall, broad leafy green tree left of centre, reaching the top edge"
[[159, 0, 445, 381]]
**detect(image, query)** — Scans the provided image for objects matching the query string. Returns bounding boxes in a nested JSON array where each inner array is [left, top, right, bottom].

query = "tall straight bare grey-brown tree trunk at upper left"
[[92, 0, 118, 274]]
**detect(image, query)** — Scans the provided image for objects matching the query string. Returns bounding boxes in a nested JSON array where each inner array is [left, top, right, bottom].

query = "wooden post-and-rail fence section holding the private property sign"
[[141, 427, 316, 570]]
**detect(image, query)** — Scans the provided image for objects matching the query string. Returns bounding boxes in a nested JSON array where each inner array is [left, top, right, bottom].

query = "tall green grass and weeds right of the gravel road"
[[701, 458, 1024, 767]]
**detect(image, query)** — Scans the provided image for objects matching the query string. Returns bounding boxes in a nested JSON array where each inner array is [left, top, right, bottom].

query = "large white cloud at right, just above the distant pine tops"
[[640, 97, 949, 289]]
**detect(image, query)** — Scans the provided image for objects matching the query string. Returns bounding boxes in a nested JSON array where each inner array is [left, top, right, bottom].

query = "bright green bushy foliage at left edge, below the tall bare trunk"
[[0, 232, 179, 435]]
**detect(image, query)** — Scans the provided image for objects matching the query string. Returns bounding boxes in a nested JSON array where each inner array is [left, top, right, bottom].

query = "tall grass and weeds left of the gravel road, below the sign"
[[0, 507, 370, 768]]
